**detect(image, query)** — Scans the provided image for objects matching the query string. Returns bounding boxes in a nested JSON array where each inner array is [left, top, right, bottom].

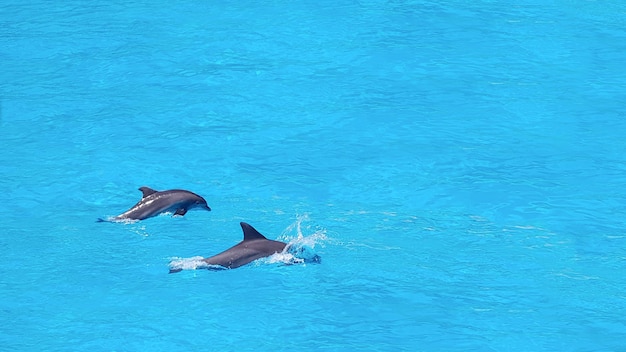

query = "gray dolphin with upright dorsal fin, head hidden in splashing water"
[[170, 222, 287, 273]]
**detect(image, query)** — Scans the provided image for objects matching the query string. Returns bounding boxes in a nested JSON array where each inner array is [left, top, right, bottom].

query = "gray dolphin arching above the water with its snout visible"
[[98, 187, 211, 221]]
